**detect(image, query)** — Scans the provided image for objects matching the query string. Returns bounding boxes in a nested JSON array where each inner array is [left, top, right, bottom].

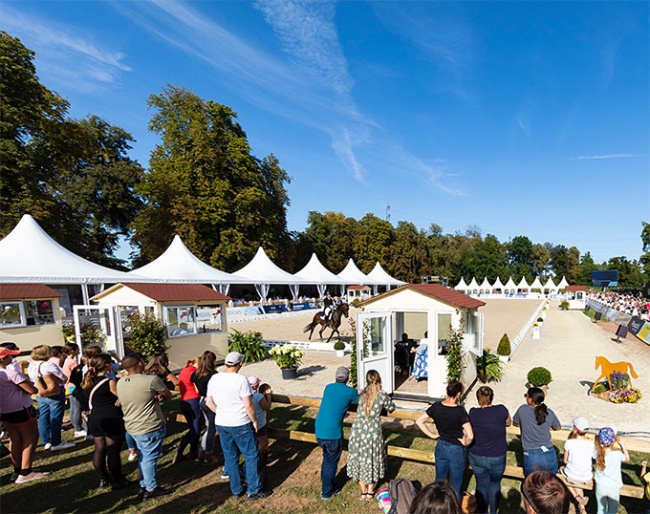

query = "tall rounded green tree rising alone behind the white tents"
[[133, 86, 289, 271]]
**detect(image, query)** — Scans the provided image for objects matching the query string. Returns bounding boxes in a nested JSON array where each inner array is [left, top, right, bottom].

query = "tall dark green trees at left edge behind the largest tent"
[[0, 32, 143, 266]]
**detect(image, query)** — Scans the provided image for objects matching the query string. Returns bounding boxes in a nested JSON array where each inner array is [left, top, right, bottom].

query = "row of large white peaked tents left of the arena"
[[0, 214, 405, 303]]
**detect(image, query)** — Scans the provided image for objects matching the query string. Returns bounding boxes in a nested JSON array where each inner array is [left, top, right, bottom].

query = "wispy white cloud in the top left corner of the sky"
[[2, 3, 131, 91]]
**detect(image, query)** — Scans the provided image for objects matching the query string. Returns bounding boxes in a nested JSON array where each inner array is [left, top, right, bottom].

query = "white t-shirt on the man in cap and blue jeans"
[[207, 373, 253, 427]]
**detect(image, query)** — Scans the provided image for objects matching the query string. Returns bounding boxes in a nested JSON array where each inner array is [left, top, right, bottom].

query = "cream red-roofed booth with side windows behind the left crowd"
[[90, 283, 230, 369]]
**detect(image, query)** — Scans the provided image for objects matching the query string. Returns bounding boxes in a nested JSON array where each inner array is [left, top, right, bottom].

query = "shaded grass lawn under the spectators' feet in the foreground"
[[0, 401, 643, 514]]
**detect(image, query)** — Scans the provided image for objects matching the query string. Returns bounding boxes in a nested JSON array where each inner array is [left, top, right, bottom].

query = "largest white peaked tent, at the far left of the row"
[[0, 214, 143, 303]]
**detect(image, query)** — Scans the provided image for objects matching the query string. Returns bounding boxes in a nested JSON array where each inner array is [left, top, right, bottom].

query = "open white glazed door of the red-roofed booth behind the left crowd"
[[74, 305, 124, 359]]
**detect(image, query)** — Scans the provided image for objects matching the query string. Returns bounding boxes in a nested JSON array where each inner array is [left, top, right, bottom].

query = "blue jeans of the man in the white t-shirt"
[[217, 423, 262, 496]]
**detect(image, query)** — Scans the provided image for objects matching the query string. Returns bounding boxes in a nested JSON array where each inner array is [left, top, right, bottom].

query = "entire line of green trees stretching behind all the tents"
[[0, 32, 650, 289]]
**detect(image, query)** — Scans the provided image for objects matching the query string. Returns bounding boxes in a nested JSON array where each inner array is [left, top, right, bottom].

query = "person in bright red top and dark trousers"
[[172, 357, 203, 464]]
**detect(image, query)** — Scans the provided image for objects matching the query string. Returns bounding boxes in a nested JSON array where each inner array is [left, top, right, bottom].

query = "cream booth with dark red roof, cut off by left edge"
[[0, 284, 63, 351]]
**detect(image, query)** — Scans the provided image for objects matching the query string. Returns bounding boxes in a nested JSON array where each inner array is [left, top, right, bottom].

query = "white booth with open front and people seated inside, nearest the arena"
[[356, 284, 485, 401]]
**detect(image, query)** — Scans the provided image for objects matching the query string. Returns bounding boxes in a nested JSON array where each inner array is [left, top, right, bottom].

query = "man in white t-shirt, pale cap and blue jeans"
[[206, 352, 268, 500]]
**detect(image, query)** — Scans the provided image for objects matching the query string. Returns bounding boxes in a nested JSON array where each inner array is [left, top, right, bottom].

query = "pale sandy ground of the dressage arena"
[[230, 299, 650, 440]]
